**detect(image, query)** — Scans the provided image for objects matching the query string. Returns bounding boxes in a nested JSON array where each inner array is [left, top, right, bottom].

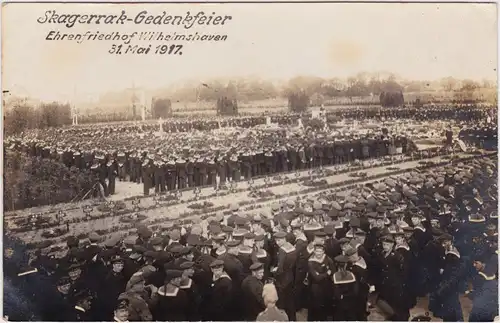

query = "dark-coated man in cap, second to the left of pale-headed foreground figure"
[[203, 259, 234, 321]]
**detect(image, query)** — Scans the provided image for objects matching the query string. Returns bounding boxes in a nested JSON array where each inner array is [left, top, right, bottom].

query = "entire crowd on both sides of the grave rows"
[[4, 106, 499, 322]]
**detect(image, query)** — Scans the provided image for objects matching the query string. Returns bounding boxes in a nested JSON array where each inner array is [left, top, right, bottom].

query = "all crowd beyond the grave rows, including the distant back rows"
[[4, 106, 496, 201]]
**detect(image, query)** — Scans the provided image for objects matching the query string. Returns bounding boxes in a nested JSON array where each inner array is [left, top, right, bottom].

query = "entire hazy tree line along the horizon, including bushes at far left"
[[4, 73, 496, 135]]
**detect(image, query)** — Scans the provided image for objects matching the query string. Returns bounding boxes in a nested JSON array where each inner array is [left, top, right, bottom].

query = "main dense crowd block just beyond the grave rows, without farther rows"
[[8, 117, 417, 199]]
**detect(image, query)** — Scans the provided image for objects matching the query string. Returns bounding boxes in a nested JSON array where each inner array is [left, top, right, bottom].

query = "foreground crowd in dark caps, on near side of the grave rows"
[[4, 157, 498, 322]]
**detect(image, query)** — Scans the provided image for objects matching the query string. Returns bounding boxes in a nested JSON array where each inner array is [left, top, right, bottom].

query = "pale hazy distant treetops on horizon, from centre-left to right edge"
[[161, 73, 496, 104]]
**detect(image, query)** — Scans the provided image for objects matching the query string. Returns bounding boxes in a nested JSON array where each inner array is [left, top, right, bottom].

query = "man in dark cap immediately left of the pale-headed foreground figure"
[[241, 262, 265, 321]]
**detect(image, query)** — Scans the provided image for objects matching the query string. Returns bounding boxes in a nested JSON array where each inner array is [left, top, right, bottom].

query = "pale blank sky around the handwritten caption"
[[2, 4, 497, 100]]
